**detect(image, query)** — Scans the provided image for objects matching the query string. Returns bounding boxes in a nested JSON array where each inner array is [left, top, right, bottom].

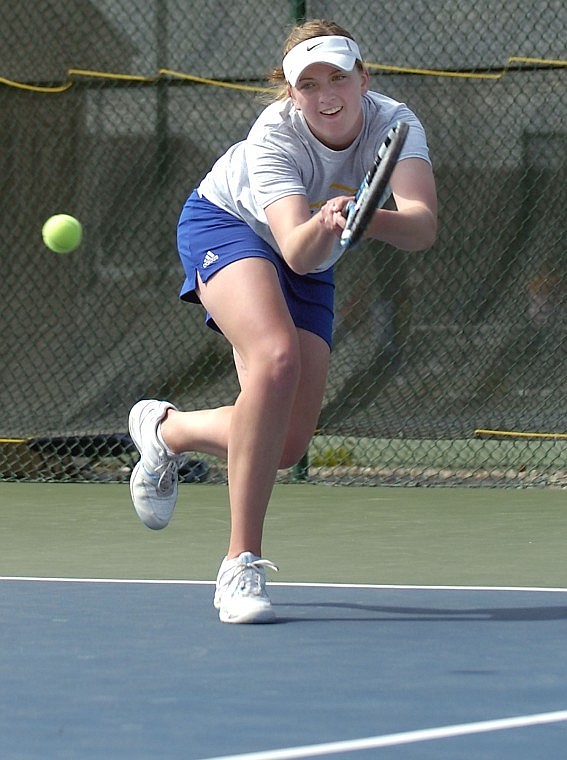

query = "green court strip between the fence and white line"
[[0, 482, 567, 588]]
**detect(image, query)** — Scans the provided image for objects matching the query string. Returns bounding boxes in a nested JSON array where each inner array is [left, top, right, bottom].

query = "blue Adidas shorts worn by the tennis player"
[[177, 191, 335, 346]]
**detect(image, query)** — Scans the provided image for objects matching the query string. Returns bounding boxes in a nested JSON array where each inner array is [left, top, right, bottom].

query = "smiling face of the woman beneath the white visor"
[[289, 63, 368, 150]]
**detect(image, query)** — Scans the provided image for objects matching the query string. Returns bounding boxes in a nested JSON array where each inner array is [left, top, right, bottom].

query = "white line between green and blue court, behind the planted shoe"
[[0, 575, 567, 594]]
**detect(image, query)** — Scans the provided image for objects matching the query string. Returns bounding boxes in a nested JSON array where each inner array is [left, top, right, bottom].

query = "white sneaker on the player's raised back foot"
[[128, 400, 184, 530]]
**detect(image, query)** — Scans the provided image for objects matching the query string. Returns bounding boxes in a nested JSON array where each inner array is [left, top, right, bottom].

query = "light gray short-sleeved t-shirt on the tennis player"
[[198, 92, 430, 272]]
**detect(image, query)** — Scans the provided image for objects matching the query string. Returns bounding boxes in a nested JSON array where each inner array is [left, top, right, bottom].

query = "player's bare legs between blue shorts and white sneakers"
[[162, 259, 328, 557]]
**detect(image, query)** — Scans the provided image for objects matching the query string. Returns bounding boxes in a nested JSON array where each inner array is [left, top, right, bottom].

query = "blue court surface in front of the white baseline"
[[0, 579, 567, 760]]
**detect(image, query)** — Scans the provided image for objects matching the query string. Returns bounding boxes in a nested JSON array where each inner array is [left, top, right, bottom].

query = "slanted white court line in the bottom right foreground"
[[203, 710, 567, 760]]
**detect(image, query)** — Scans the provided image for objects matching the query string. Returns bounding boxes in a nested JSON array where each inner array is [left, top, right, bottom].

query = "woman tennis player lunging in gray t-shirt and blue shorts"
[[129, 20, 437, 623]]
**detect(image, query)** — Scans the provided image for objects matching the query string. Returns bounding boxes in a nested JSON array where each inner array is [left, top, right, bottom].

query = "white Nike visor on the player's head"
[[282, 35, 362, 87]]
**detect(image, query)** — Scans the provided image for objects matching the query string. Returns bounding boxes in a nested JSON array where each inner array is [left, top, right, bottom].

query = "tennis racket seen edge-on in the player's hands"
[[341, 121, 409, 250]]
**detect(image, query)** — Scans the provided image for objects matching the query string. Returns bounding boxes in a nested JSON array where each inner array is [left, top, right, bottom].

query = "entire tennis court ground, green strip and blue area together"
[[0, 483, 567, 760]]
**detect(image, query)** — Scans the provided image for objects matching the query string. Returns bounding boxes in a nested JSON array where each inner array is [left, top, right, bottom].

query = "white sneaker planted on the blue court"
[[214, 552, 278, 623]]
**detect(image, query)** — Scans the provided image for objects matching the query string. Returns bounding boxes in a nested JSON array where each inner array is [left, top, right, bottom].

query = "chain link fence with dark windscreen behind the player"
[[0, 0, 567, 486]]
